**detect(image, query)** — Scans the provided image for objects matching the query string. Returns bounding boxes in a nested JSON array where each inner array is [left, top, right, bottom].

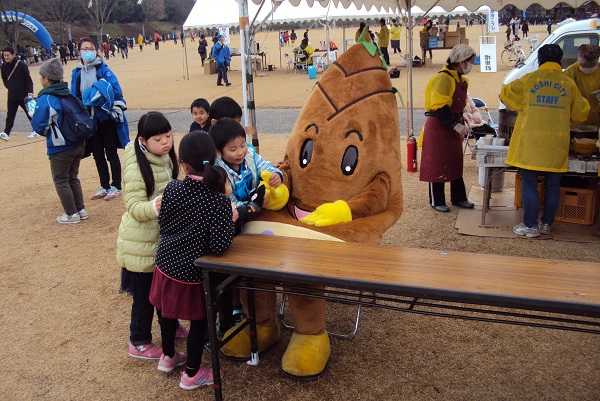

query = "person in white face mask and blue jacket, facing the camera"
[[71, 38, 129, 200]]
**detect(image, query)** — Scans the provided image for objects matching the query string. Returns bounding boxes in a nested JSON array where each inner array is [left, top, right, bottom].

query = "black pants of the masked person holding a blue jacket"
[[88, 121, 121, 191]]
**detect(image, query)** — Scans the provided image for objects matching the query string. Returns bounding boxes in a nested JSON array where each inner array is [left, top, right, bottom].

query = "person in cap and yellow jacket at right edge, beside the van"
[[565, 44, 600, 127]]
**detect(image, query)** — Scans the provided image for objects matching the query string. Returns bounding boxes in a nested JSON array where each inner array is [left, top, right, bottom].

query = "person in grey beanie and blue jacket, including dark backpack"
[[31, 58, 93, 224]]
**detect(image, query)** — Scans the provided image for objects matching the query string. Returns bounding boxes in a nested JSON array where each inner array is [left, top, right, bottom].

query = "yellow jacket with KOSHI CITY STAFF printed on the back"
[[500, 62, 590, 173]]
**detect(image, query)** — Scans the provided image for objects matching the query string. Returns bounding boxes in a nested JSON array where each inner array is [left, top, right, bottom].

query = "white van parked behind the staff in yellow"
[[502, 18, 600, 85]]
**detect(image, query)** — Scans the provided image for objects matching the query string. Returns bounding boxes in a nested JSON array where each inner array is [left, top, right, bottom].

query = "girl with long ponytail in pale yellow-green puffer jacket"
[[117, 111, 188, 359]]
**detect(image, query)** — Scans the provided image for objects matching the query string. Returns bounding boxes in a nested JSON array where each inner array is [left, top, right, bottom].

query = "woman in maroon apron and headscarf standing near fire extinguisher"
[[419, 44, 475, 212]]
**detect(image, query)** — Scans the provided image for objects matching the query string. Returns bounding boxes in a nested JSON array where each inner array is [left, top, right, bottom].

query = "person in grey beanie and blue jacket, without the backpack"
[[31, 58, 88, 224]]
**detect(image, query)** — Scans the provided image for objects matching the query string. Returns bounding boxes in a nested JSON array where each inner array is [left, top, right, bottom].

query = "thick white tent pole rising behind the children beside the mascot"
[[238, 0, 259, 152]]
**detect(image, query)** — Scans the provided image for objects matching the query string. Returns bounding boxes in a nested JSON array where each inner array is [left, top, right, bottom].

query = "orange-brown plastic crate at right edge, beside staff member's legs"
[[555, 185, 600, 225]]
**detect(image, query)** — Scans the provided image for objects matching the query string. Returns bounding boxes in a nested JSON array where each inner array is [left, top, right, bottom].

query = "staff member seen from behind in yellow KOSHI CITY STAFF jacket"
[[500, 44, 590, 237]]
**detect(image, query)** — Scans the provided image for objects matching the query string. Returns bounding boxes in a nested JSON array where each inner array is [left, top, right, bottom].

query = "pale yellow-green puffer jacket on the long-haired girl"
[[117, 142, 173, 273]]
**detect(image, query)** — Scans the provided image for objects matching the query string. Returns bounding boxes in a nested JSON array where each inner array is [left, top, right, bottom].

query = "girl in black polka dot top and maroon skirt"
[[150, 131, 236, 390]]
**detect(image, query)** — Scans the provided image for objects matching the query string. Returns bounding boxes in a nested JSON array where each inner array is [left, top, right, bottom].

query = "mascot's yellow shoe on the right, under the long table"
[[281, 332, 331, 380]]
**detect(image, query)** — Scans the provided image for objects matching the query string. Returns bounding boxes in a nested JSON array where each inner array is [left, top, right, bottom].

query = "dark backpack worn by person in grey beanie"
[[54, 94, 95, 144]]
